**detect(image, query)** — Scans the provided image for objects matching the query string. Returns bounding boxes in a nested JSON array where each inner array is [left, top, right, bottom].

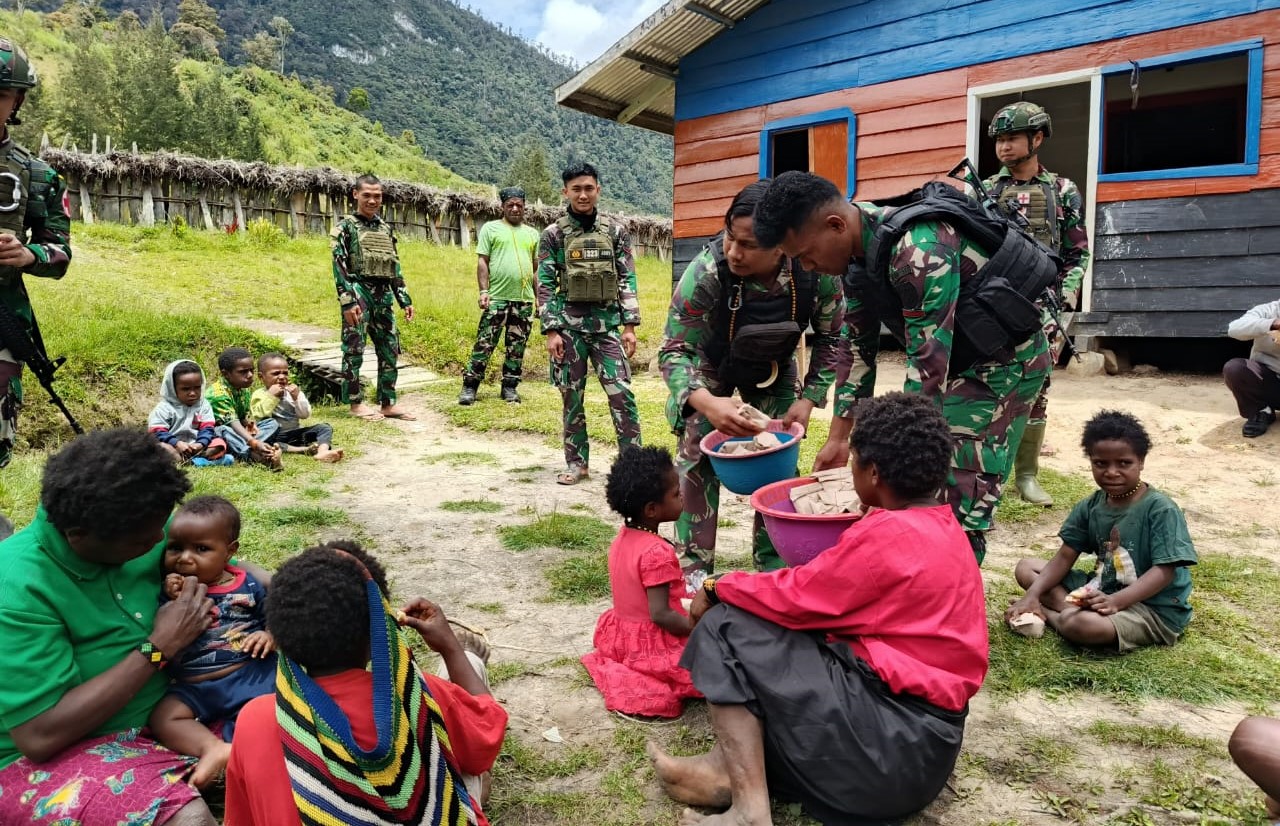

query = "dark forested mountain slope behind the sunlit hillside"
[[102, 0, 672, 215]]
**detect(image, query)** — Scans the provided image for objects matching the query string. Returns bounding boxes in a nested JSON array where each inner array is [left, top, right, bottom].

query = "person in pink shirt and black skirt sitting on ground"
[[649, 393, 987, 826]]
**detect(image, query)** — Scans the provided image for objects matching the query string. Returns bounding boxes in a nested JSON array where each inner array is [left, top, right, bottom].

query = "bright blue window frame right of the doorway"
[[1098, 37, 1263, 183]]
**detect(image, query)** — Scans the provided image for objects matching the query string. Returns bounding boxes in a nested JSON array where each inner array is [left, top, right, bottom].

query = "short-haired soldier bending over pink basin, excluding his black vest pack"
[[755, 172, 1050, 562]]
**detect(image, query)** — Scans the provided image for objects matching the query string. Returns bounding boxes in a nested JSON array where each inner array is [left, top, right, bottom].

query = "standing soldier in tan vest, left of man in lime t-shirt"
[[330, 175, 415, 421]]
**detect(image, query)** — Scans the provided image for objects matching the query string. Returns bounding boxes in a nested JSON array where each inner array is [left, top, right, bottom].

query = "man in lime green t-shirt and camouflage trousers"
[[458, 187, 538, 405]]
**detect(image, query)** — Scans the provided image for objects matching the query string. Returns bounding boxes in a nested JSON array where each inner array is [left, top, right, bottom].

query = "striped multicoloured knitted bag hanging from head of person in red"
[[275, 579, 477, 826]]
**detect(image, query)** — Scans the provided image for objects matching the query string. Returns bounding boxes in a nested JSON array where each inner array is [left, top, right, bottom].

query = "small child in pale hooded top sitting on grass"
[[147, 359, 230, 465]]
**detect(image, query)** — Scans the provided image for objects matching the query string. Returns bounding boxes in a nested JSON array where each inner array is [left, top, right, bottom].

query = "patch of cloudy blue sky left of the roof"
[[462, 0, 663, 65]]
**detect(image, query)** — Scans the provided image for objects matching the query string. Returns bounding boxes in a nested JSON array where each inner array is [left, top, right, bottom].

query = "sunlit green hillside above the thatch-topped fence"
[[0, 10, 489, 191]]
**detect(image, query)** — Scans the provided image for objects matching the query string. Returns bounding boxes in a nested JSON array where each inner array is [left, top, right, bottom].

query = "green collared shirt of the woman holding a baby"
[[0, 508, 166, 768]]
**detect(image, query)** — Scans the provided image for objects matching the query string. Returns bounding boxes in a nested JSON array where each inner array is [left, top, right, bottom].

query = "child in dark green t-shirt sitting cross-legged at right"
[[1005, 410, 1196, 652]]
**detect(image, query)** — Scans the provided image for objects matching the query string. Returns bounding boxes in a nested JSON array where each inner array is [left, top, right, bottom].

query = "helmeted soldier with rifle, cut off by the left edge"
[[0, 36, 72, 467]]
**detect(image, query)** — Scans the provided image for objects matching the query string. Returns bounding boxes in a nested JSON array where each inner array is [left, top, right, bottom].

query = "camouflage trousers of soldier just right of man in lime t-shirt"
[[550, 329, 640, 467]]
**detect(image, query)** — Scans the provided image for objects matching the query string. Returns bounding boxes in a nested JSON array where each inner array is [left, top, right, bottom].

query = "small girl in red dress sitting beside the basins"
[[582, 447, 699, 717]]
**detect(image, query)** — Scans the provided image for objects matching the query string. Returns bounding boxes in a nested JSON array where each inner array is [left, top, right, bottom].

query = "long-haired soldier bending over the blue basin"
[[658, 179, 849, 578]]
